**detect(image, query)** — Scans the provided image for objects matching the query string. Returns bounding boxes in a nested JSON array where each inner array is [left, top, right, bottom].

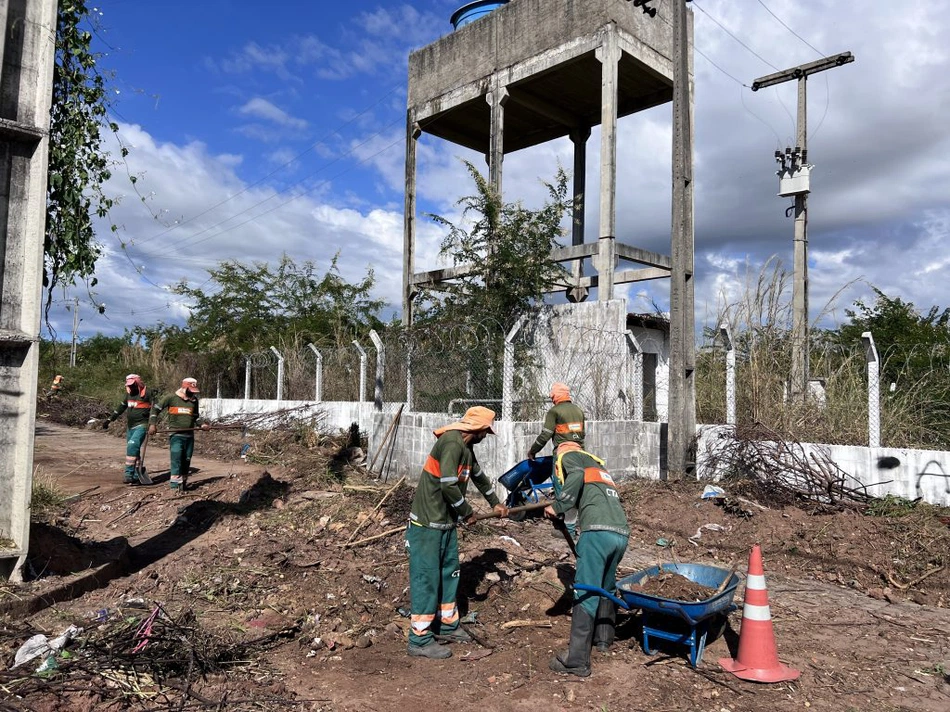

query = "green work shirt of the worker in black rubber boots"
[[551, 450, 630, 536]]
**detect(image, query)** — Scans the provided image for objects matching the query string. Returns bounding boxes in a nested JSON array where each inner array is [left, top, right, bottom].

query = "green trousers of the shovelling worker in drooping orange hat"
[[406, 524, 459, 645]]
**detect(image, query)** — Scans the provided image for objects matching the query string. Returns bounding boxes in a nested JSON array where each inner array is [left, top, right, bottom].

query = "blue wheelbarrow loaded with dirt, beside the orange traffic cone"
[[574, 564, 739, 668]]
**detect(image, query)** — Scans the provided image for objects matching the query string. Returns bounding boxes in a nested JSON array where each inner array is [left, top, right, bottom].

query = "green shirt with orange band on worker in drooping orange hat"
[[409, 430, 498, 529]]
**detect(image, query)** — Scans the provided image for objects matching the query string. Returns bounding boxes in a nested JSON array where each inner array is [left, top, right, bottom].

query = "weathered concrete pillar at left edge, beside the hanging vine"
[[0, 0, 56, 578]]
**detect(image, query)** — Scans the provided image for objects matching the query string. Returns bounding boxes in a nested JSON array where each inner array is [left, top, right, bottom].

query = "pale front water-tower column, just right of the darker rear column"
[[594, 25, 620, 301]]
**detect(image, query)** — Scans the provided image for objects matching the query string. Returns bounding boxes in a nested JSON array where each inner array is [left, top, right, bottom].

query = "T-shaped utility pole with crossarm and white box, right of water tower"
[[752, 52, 854, 401]]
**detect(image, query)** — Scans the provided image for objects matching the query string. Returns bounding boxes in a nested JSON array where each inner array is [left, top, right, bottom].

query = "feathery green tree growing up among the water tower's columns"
[[417, 161, 572, 327]]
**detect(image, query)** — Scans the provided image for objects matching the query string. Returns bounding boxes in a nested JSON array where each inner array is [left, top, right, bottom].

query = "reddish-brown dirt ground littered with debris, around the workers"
[[0, 422, 950, 712]]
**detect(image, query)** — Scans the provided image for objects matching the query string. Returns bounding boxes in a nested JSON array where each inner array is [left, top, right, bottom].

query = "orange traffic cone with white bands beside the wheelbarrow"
[[719, 544, 801, 682]]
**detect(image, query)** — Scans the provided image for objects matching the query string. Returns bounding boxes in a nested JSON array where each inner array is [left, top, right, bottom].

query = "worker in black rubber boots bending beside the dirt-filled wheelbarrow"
[[544, 444, 630, 677]]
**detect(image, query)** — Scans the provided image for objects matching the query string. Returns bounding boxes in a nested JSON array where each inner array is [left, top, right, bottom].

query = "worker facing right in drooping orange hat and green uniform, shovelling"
[[406, 406, 508, 658]]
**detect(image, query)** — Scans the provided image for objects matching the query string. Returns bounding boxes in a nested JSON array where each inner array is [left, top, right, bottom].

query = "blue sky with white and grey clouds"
[[52, 0, 950, 338]]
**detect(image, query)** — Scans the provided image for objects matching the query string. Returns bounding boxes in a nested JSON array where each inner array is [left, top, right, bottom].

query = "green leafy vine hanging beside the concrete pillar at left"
[[43, 0, 116, 313]]
